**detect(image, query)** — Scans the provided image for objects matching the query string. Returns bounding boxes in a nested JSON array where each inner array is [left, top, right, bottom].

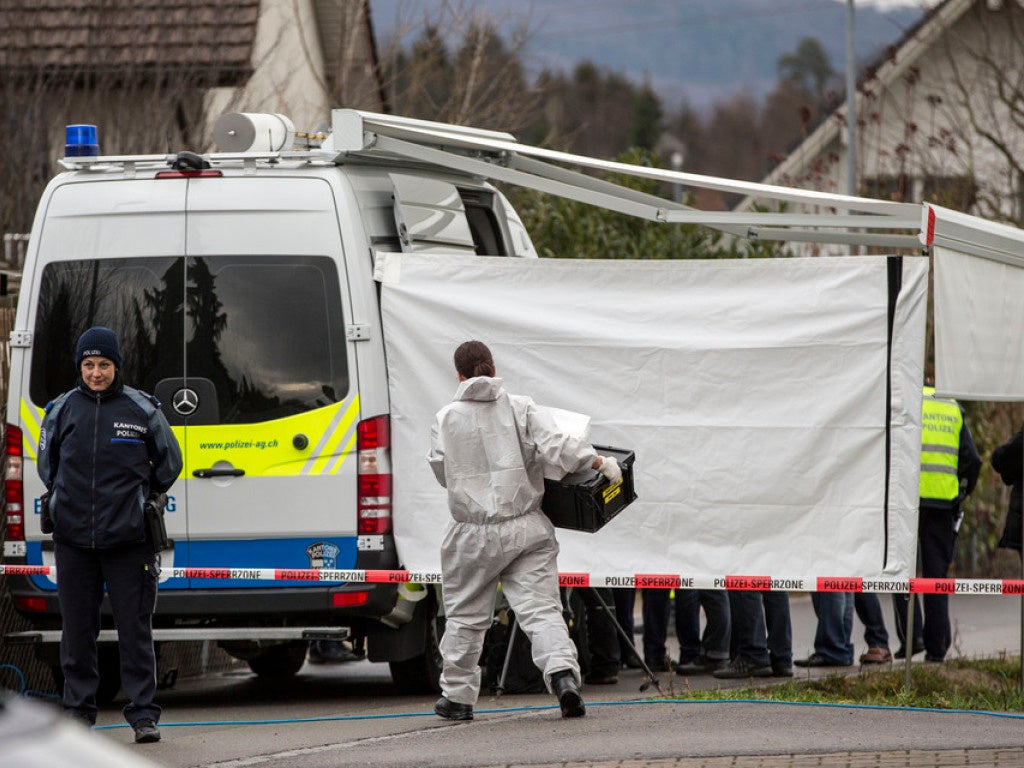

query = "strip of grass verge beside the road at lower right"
[[671, 657, 1024, 713]]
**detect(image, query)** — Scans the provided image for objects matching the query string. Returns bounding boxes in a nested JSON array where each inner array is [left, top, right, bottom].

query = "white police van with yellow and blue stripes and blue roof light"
[[4, 111, 537, 698]]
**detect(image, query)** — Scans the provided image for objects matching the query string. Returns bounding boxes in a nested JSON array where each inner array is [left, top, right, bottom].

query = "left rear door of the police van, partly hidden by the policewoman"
[[24, 178, 187, 590]]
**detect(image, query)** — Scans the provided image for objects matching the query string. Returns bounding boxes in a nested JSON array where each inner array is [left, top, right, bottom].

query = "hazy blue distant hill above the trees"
[[371, 0, 923, 110]]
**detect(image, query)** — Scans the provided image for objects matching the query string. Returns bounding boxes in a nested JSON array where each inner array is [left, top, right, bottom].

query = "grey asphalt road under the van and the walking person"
[[77, 595, 1024, 768]]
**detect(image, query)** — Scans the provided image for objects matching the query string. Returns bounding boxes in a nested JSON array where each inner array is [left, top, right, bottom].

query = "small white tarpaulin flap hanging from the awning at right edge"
[[934, 246, 1024, 400]]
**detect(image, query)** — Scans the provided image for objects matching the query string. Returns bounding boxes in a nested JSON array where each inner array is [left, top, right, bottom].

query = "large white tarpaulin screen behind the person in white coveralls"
[[378, 254, 928, 578]]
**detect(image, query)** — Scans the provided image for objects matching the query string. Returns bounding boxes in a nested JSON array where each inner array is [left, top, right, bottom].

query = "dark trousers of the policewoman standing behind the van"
[[54, 544, 160, 723]]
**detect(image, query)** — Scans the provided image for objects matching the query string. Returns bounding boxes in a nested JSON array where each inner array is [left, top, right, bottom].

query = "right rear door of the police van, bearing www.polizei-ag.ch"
[[174, 176, 359, 588]]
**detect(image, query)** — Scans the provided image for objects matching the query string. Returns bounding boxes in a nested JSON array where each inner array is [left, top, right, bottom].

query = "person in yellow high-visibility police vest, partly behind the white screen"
[[893, 379, 981, 662]]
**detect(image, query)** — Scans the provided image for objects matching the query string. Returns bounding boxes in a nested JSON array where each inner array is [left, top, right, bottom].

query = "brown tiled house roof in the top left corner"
[[0, 0, 260, 85]]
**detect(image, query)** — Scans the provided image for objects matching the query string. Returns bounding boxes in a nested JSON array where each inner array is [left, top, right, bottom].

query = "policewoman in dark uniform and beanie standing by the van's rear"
[[38, 327, 181, 742]]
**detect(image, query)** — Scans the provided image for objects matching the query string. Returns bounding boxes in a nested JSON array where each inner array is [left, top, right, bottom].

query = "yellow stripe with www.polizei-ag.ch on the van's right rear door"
[[187, 395, 359, 477]]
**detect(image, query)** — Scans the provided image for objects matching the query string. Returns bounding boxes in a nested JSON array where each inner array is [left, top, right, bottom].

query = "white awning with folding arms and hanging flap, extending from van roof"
[[333, 110, 1024, 409]]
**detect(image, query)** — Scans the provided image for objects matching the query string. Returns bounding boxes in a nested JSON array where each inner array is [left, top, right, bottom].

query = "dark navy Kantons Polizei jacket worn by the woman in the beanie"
[[38, 377, 181, 549]]
